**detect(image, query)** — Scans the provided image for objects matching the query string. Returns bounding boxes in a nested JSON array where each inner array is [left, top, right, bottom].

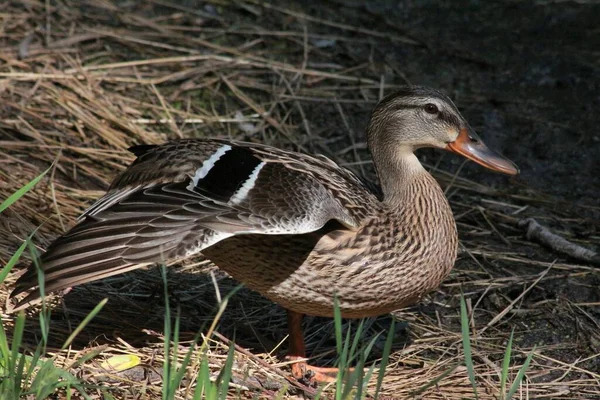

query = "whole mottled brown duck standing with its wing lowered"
[[12, 86, 518, 380]]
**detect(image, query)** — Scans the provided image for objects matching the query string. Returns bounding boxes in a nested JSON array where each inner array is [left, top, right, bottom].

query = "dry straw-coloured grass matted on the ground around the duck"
[[0, 0, 600, 399]]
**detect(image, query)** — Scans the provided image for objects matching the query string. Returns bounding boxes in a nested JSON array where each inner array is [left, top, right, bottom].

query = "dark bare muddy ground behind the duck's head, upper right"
[[296, 0, 600, 206]]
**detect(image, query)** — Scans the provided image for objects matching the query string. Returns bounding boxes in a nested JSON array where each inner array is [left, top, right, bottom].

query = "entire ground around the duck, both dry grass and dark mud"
[[0, 0, 600, 399]]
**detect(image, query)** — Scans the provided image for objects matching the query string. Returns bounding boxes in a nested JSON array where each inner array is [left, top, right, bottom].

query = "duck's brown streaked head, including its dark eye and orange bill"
[[368, 86, 519, 175]]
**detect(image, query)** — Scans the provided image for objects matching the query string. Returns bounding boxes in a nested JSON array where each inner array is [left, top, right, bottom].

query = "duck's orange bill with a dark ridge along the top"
[[446, 128, 519, 175]]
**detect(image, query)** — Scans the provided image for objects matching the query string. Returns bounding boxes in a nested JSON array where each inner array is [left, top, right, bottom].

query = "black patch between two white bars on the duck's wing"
[[194, 147, 262, 201]]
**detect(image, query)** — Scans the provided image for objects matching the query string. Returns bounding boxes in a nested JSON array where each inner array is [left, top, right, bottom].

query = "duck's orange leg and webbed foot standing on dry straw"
[[287, 310, 338, 382]]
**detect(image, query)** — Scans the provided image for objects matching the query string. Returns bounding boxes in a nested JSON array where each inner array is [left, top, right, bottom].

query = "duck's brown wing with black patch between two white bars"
[[11, 139, 376, 308]]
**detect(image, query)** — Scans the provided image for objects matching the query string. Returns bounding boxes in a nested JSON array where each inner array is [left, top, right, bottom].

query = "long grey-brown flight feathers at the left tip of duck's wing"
[[11, 218, 196, 310]]
